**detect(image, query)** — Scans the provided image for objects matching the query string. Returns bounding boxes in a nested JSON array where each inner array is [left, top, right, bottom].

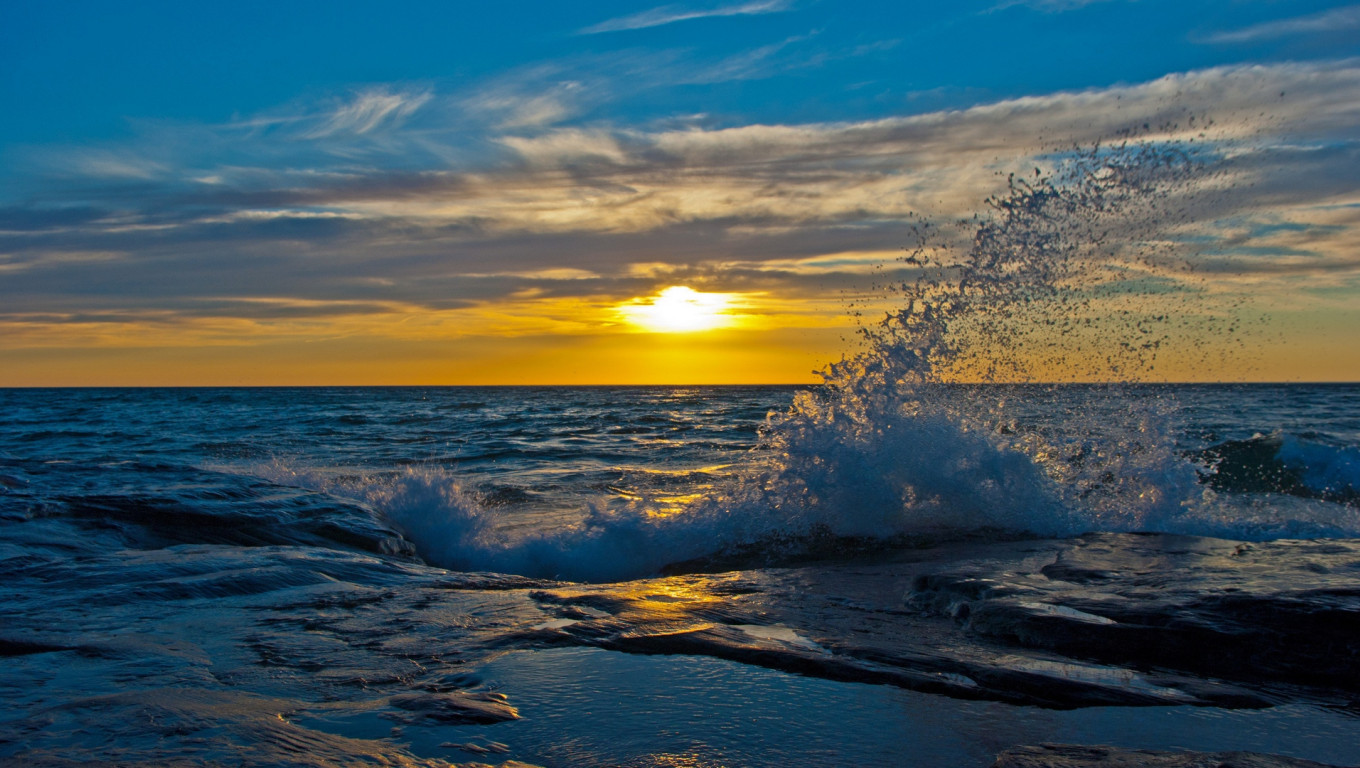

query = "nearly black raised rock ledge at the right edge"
[[908, 534, 1360, 693]]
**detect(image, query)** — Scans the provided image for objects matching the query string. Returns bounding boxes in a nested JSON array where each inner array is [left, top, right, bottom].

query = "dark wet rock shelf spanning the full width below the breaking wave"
[[0, 519, 1360, 765]]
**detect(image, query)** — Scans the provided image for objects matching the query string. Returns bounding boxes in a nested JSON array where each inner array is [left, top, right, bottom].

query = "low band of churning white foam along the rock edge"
[[262, 418, 1360, 582]]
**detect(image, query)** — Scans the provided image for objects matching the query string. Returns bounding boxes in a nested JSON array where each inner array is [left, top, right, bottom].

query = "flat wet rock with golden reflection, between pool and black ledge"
[[517, 554, 1269, 708]]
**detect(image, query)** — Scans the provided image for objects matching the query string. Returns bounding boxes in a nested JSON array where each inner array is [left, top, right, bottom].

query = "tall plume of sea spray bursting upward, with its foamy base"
[[734, 135, 1221, 536]]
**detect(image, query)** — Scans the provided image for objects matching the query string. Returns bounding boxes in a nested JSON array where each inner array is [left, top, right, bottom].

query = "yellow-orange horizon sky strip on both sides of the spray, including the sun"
[[0, 281, 1360, 387]]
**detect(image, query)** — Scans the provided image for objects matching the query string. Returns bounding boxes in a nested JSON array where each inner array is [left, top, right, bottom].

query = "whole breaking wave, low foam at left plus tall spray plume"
[[259, 134, 1360, 580]]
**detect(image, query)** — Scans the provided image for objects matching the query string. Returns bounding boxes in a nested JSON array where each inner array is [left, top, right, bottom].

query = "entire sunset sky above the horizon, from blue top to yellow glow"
[[0, 0, 1360, 386]]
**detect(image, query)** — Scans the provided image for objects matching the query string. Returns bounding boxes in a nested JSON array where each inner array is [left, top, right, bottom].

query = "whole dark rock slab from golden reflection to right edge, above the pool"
[[522, 534, 1360, 708]]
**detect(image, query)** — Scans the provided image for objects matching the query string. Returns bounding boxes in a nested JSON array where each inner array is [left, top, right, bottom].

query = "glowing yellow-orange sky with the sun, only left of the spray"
[[0, 287, 851, 386]]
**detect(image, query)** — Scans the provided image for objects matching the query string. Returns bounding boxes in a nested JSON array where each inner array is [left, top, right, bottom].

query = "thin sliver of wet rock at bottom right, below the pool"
[[991, 744, 1334, 768]]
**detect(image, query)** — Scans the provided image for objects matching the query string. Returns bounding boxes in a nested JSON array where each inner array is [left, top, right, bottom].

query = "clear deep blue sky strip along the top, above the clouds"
[[0, 0, 1360, 146]]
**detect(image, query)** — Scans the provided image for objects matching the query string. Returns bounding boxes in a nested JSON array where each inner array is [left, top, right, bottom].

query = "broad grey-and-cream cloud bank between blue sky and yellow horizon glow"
[[0, 61, 1360, 344]]
